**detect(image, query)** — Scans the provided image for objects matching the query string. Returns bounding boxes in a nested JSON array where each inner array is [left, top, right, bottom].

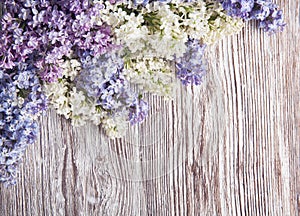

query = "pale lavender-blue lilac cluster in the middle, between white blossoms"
[[75, 54, 148, 124]]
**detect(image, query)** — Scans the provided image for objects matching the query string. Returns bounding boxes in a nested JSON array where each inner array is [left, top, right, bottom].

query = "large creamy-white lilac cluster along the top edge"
[[101, 0, 243, 51]]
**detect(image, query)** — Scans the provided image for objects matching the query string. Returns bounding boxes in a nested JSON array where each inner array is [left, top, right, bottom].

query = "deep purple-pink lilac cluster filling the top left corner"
[[0, 0, 112, 82]]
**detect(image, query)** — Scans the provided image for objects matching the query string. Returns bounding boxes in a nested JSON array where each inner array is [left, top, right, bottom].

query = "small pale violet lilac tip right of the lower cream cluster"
[[176, 40, 206, 85]]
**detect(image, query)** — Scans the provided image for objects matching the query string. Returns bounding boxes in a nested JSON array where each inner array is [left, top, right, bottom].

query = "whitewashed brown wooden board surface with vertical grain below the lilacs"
[[0, 0, 300, 216]]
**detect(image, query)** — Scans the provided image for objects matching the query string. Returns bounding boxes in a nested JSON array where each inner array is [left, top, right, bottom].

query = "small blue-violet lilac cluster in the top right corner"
[[220, 0, 286, 34]]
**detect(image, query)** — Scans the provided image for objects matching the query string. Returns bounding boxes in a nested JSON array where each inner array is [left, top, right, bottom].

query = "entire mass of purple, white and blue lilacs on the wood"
[[0, 0, 285, 184]]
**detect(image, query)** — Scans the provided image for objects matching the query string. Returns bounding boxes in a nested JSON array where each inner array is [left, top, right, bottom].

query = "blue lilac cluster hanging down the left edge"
[[0, 64, 47, 185]]
